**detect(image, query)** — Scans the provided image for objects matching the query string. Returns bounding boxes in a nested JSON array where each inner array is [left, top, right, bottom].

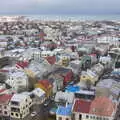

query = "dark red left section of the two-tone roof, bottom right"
[[73, 99, 91, 113]]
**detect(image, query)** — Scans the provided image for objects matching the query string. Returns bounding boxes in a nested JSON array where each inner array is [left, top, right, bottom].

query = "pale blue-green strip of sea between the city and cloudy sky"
[[26, 15, 120, 21]]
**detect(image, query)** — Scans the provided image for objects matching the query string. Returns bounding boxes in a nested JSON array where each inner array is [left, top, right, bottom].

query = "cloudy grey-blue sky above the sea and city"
[[0, 0, 120, 15]]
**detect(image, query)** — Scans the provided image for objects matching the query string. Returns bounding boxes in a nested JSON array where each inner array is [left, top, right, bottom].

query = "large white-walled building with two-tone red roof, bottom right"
[[72, 97, 116, 120]]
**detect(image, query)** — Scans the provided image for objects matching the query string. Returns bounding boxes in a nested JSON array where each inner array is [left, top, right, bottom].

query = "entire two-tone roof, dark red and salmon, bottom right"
[[73, 97, 116, 117]]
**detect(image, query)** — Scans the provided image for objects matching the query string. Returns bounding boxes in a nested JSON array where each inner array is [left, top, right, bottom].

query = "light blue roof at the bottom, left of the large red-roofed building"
[[56, 105, 72, 116]]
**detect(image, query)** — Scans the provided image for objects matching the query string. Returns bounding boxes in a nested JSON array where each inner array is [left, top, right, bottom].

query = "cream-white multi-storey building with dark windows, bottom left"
[[10, 94, 32, 118]]
